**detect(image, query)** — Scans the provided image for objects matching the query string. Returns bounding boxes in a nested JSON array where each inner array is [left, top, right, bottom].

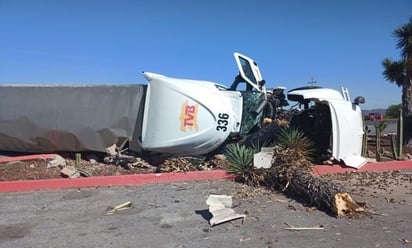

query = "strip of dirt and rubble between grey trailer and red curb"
[[0, 154, 227, 182]]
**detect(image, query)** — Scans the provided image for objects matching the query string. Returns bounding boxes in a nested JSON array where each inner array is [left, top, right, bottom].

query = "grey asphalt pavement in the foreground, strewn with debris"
[[0, 175, 412, 248]]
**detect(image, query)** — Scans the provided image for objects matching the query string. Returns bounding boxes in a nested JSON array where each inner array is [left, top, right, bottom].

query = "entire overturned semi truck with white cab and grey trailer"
[[0, 53, 366, 168]]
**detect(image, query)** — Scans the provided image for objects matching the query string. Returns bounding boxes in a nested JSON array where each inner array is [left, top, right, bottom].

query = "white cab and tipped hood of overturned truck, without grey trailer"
[[140, 53, 366, 168]]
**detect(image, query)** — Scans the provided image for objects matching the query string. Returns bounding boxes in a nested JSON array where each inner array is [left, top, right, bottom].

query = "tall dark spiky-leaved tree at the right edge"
[[382, 17, 412, 144]]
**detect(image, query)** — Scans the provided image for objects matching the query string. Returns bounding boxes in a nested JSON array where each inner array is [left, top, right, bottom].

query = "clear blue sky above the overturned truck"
[[0, 0, 412, 109]]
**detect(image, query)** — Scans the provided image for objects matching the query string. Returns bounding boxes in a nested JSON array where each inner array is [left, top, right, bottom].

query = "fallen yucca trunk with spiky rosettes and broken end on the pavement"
[[226, 128, 364, 218]]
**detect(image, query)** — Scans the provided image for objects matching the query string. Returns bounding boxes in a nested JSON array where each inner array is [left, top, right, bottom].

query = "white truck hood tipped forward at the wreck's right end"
[[288, 87, 367, 168]]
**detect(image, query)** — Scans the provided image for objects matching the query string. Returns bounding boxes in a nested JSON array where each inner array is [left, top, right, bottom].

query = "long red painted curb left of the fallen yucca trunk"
[[0, 170, 232, 192]]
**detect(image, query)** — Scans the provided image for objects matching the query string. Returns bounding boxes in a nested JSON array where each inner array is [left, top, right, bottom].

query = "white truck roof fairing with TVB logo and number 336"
[[142, 72, 242, 155]]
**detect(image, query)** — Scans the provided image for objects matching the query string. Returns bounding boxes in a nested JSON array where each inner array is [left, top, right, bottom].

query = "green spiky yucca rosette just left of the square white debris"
[[225, 144, 263, 186]]
